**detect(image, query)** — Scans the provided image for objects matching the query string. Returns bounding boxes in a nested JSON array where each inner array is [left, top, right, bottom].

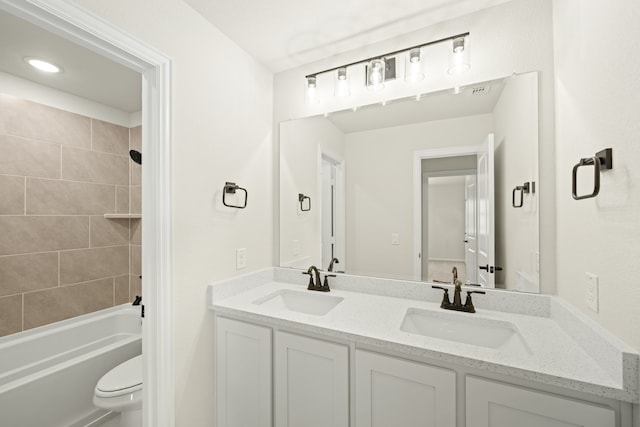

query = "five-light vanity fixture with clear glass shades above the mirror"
[[305, 33, 470, 104]]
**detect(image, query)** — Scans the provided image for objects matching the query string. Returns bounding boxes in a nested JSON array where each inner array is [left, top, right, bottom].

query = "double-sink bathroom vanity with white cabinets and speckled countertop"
[[208, 268, 640, 427]]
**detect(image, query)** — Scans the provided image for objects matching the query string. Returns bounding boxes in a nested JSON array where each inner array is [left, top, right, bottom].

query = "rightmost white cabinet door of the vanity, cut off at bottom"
[[466, 377, 616, 427]]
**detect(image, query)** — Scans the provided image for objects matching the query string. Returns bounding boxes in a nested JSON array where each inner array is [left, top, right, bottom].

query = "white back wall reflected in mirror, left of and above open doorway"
[[345, 114, 493, 280]]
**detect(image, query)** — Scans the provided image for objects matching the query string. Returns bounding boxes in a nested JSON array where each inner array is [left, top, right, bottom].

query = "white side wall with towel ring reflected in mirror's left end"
[[280, 117, 344, 268]]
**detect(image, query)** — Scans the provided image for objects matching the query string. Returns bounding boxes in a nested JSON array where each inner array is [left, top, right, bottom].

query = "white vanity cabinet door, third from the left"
[[355, 350, 456, 427]]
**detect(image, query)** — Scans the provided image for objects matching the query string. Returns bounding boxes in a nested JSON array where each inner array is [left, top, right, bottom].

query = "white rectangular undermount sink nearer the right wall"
[[400, 308, 531, 353]]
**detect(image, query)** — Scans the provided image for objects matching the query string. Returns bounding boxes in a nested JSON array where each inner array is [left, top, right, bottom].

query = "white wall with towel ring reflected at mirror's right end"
[[493, 73, 536, 291]]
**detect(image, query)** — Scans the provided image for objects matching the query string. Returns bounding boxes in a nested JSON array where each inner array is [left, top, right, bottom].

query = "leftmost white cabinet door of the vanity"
[[215, 317, 271, 427]]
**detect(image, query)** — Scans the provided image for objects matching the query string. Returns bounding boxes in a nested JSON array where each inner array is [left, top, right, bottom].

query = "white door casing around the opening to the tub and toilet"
[[0, 0, 175, 427]]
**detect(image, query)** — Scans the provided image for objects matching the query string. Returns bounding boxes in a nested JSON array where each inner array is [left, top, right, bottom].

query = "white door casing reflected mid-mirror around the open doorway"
[[412, 145, 478, 281]]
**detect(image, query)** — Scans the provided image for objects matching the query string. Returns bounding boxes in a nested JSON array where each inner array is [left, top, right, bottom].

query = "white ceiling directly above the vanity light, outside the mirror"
[[185, 0, 509, 72]]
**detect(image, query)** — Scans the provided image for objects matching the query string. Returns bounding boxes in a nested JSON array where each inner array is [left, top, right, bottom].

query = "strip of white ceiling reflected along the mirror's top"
[[327, 79, 504, 133]]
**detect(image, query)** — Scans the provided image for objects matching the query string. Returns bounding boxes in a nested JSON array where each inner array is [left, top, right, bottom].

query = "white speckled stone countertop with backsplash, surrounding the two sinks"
[[208, 268, 640, 403]]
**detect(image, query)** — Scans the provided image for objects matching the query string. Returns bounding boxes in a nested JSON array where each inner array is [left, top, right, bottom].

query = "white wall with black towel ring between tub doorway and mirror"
[[71, 0, 273, 426]]
